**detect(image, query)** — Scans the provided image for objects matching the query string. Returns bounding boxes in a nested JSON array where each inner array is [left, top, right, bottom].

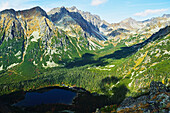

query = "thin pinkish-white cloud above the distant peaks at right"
[[134, 9, 168, 17]]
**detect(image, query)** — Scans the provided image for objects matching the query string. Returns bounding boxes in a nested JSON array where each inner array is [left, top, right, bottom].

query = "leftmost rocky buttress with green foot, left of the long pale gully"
[[0, 9, 25, 70]]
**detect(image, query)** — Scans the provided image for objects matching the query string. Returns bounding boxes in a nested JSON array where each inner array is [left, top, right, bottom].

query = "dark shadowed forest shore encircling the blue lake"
[[0, 86, 109, 112]]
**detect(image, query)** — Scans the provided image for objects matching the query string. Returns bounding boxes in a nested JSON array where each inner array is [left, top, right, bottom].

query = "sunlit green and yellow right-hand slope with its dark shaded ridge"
[[95, 26, 170, 96]]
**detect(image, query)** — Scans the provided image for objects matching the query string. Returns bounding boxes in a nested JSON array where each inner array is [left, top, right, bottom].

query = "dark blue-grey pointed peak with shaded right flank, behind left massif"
[[48, 7, 106, 40]]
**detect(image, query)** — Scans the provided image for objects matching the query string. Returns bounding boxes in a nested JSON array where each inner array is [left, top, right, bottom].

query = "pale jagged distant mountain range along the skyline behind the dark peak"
[[48, 7, 170, 39]]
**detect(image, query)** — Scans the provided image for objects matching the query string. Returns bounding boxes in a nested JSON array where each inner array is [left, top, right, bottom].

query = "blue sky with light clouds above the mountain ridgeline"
[[0, 0, 170, 23]]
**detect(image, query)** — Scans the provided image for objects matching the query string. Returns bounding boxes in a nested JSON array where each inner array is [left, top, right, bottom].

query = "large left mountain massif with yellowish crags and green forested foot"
[[0, 7, 105, 70]]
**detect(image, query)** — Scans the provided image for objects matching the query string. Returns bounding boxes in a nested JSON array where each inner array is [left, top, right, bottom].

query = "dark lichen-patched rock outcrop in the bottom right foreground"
[[117, 81, 170, 113]]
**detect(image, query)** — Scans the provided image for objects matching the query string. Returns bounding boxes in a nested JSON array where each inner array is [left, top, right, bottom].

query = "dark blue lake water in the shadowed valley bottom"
[[14, 89, 76, 106]]
